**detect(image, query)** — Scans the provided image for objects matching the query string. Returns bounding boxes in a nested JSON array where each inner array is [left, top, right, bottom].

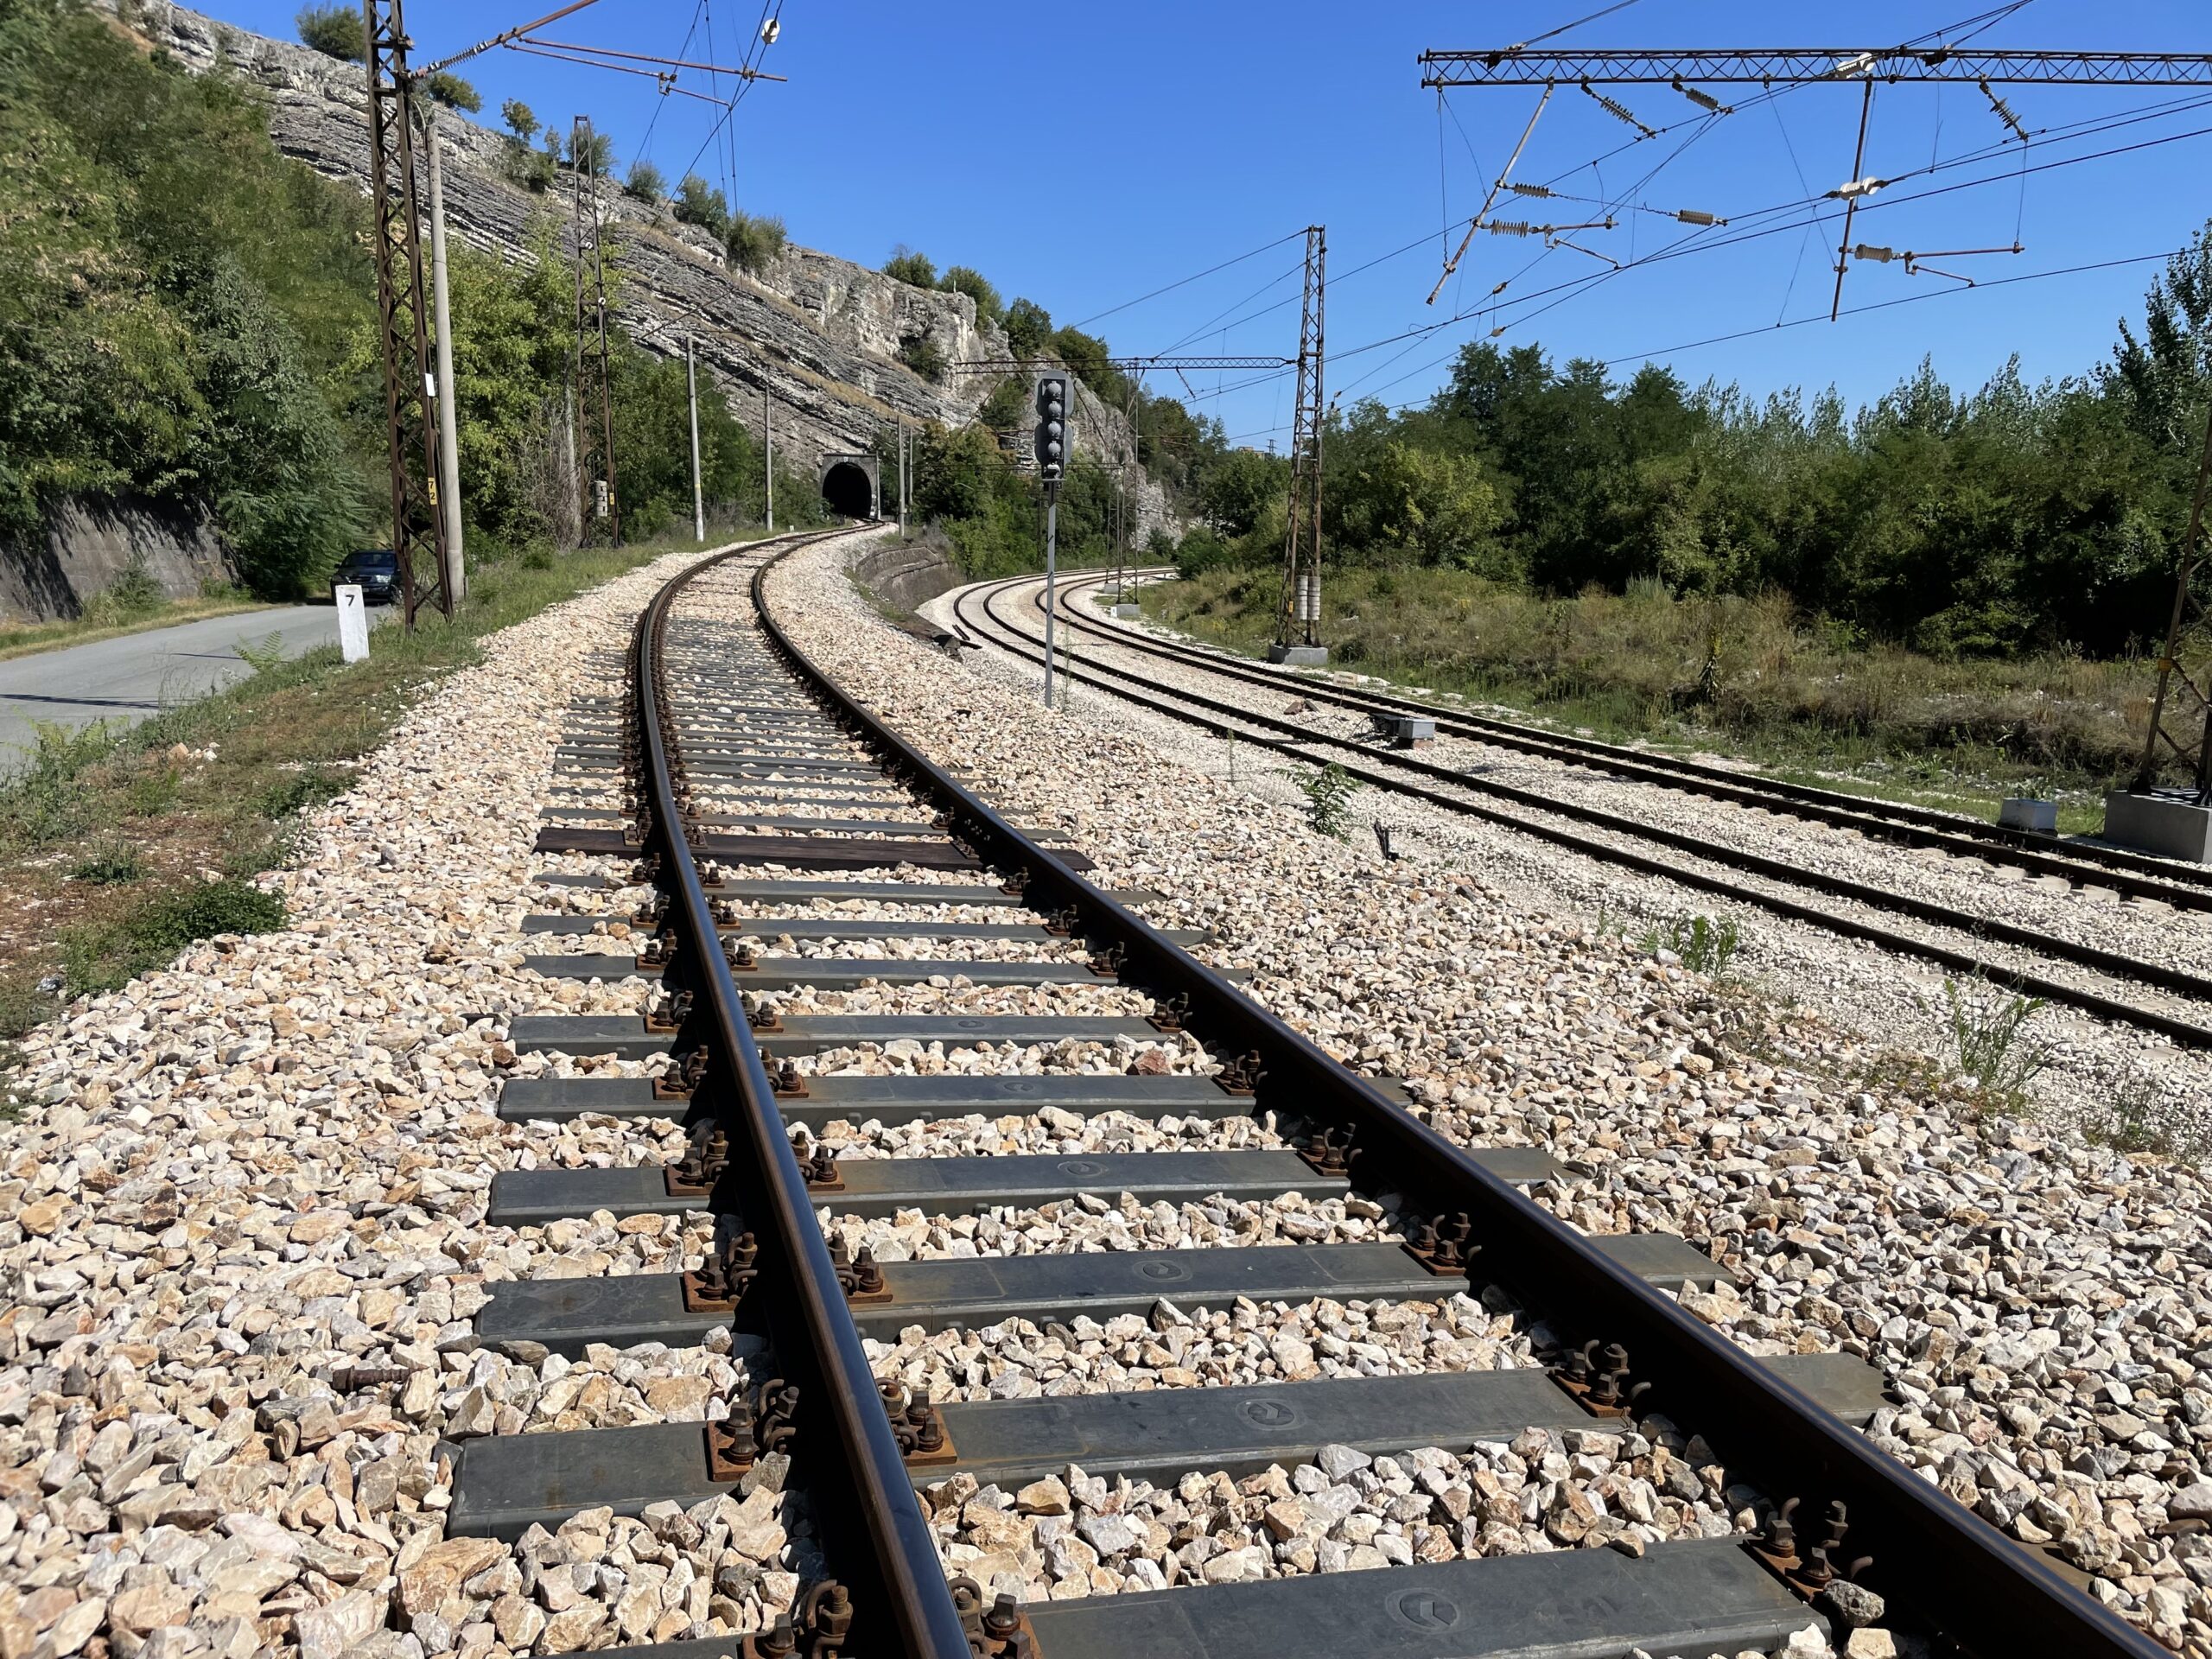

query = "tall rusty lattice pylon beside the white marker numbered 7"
[[360, 0, 454, 628]]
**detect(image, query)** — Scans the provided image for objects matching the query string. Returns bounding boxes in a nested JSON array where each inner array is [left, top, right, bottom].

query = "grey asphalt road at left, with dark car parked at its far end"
[[0, 604, 391, 772]]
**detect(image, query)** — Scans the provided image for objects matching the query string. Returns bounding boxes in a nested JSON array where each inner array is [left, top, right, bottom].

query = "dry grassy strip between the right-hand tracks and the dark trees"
[[1141, 569, 2152, 834]]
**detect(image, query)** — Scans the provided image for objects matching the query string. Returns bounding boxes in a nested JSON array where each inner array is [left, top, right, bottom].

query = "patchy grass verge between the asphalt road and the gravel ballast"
[[0, 531, 761, 1106]]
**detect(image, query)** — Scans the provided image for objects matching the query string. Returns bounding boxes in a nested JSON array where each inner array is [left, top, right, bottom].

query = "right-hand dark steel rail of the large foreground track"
[[752, 556, 2165, 1659]]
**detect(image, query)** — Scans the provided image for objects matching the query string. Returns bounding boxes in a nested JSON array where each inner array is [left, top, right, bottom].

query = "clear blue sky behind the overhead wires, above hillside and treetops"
[[217, 0, 2212, 442]]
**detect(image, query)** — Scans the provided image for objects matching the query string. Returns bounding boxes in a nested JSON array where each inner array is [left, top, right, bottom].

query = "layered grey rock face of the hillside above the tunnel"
[[119, 0, 1164, 529]]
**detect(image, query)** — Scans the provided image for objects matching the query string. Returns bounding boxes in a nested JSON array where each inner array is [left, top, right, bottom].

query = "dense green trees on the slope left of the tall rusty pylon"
[[0, 4, 372, 597]]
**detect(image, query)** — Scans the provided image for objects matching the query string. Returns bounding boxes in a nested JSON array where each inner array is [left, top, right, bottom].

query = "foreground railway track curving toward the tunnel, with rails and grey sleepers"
[[447, 539, 2161, 1659]]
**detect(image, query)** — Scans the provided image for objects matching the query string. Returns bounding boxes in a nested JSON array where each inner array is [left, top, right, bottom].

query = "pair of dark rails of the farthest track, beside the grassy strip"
[[1039, 575, 2212, 909]]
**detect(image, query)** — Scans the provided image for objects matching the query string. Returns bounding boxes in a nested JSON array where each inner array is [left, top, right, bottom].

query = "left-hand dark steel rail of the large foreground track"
[[632, 531, 969, 1659]]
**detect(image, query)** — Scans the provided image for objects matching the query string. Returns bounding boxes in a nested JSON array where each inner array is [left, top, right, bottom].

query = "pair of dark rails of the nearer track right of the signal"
[[956, 577, 2212, 1048]]
